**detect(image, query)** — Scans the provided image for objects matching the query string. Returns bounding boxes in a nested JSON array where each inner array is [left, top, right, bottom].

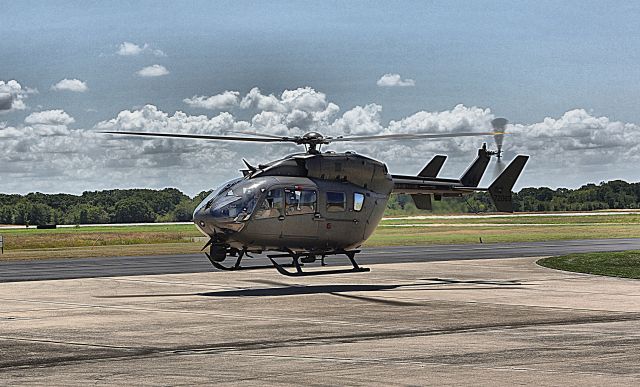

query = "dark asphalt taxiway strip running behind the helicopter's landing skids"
[[0, 238, 640, 282]]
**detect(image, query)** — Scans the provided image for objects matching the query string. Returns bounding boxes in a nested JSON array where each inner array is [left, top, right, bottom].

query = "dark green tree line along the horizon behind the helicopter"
[[0, 180, 640, 225]]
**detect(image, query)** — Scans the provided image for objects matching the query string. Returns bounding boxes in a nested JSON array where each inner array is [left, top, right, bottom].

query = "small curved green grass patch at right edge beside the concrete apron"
[[538, 250, 640, 279]]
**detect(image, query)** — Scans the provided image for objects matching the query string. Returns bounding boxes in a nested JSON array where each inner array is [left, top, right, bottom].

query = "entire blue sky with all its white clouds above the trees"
[[0, 0, 640, 195]]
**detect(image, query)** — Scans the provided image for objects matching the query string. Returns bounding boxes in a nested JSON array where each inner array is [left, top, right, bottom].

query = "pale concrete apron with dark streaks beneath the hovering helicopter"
[[0, 240, 640, 386]]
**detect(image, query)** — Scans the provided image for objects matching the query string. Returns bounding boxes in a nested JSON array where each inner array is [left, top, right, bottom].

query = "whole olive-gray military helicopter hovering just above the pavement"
[[103, 118, 529, 276]]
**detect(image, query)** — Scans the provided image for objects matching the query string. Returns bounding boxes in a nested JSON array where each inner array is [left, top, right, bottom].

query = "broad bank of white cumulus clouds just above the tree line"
[[0, 84, 640, 194]]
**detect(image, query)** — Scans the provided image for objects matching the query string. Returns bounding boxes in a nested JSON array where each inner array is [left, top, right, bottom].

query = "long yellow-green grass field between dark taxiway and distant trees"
[[0, 214, 640, 260]]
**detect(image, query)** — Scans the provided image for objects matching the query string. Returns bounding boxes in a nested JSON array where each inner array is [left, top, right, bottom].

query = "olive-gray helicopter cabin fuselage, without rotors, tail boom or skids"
[[194, 152, 393, 252]]
